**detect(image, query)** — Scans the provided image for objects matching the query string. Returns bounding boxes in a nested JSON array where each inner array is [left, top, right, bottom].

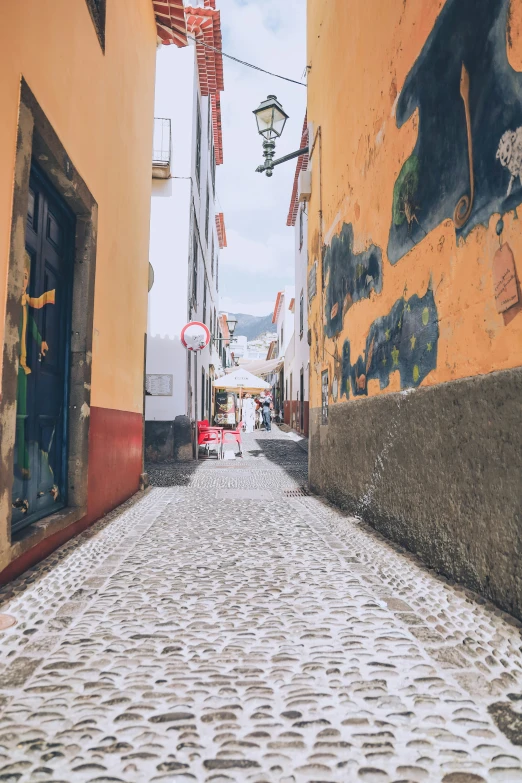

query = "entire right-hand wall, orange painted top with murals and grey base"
[[308, 0, 522, 615]]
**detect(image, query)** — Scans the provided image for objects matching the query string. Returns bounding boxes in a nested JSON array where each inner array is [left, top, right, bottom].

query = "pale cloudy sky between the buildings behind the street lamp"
[[216, 0, 306, 315]]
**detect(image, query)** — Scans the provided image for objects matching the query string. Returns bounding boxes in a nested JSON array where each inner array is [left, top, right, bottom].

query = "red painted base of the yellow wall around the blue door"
[[0, 407, 143, 585]]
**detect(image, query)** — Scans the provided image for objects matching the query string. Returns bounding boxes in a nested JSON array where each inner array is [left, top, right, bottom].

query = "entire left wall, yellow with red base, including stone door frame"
[[0, 0, 156, 581]]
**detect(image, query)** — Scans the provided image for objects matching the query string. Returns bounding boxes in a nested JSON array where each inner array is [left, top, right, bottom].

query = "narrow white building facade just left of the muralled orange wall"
[[285, 117, 310, 436]]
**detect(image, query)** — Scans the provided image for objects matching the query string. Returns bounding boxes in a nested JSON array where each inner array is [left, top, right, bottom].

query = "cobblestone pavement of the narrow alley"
[[0, 430, 522, 783]]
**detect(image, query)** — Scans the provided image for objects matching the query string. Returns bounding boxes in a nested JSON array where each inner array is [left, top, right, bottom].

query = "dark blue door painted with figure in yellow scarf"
[[12, 165, 74, 531]]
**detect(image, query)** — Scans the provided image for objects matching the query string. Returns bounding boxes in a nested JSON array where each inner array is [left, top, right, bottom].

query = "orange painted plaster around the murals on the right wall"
[[308, 0, 522, 407]]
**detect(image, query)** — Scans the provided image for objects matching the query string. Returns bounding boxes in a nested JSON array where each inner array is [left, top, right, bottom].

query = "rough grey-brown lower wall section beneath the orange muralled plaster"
[[309, 369, 522, 618]]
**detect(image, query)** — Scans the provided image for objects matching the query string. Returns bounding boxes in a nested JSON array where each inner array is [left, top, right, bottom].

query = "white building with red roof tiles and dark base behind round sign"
[[145, 0, 226, 460]]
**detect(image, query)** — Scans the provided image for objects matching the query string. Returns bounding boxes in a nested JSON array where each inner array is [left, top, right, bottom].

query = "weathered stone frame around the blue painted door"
[[0, 78, 98, 571]]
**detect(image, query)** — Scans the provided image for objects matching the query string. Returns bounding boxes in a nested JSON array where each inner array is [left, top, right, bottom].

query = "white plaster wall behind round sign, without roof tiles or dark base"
[[145, 45, 220, 440]]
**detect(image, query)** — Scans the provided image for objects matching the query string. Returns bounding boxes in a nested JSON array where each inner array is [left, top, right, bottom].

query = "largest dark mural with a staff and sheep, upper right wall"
[[388, 0, 522, 264]]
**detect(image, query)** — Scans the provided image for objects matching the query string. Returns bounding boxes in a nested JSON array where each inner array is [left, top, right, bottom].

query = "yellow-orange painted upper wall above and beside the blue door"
[[0, 0, 156, 412]]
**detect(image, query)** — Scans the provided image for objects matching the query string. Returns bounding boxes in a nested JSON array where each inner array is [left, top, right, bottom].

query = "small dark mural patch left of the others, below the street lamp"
[[323, 223, 382, 337]]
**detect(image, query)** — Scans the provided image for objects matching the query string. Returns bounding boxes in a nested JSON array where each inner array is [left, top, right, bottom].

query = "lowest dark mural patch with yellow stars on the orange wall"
[[341, 287, 439, 397]]
